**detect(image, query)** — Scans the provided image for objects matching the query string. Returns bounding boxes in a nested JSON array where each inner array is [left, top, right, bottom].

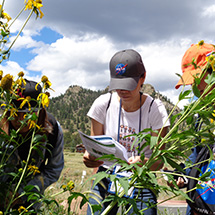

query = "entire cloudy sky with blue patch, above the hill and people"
[[0, 0, 215, 107]]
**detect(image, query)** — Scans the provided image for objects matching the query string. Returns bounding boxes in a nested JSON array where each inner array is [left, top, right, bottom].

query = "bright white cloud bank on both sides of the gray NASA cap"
[[21, 34, 190, 107]]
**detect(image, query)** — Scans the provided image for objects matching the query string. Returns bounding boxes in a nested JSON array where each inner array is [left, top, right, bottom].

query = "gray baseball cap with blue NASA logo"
[[109, 49, 146, 91]]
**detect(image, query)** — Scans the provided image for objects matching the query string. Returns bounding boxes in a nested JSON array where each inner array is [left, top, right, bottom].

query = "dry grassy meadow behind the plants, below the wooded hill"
[[44, 150, 184, 215]]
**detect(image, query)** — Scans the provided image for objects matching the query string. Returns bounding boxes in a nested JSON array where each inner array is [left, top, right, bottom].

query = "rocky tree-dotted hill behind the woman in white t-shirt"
[[48, 84, 180, 149]]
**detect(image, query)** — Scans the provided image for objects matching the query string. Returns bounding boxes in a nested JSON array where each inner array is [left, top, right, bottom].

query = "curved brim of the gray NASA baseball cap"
[[109, 77, 140, 91]]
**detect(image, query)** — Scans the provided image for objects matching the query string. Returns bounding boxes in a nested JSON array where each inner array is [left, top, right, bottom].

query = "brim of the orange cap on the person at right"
[[175, 68, 202, 89]]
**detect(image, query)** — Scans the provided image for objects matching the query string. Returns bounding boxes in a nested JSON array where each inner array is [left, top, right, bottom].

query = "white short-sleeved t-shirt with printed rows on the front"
[[87, 92, 170, 161]]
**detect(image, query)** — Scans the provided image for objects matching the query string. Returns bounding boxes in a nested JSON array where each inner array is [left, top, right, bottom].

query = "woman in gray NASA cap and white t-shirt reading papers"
[[83, 49, 169, 215]]
